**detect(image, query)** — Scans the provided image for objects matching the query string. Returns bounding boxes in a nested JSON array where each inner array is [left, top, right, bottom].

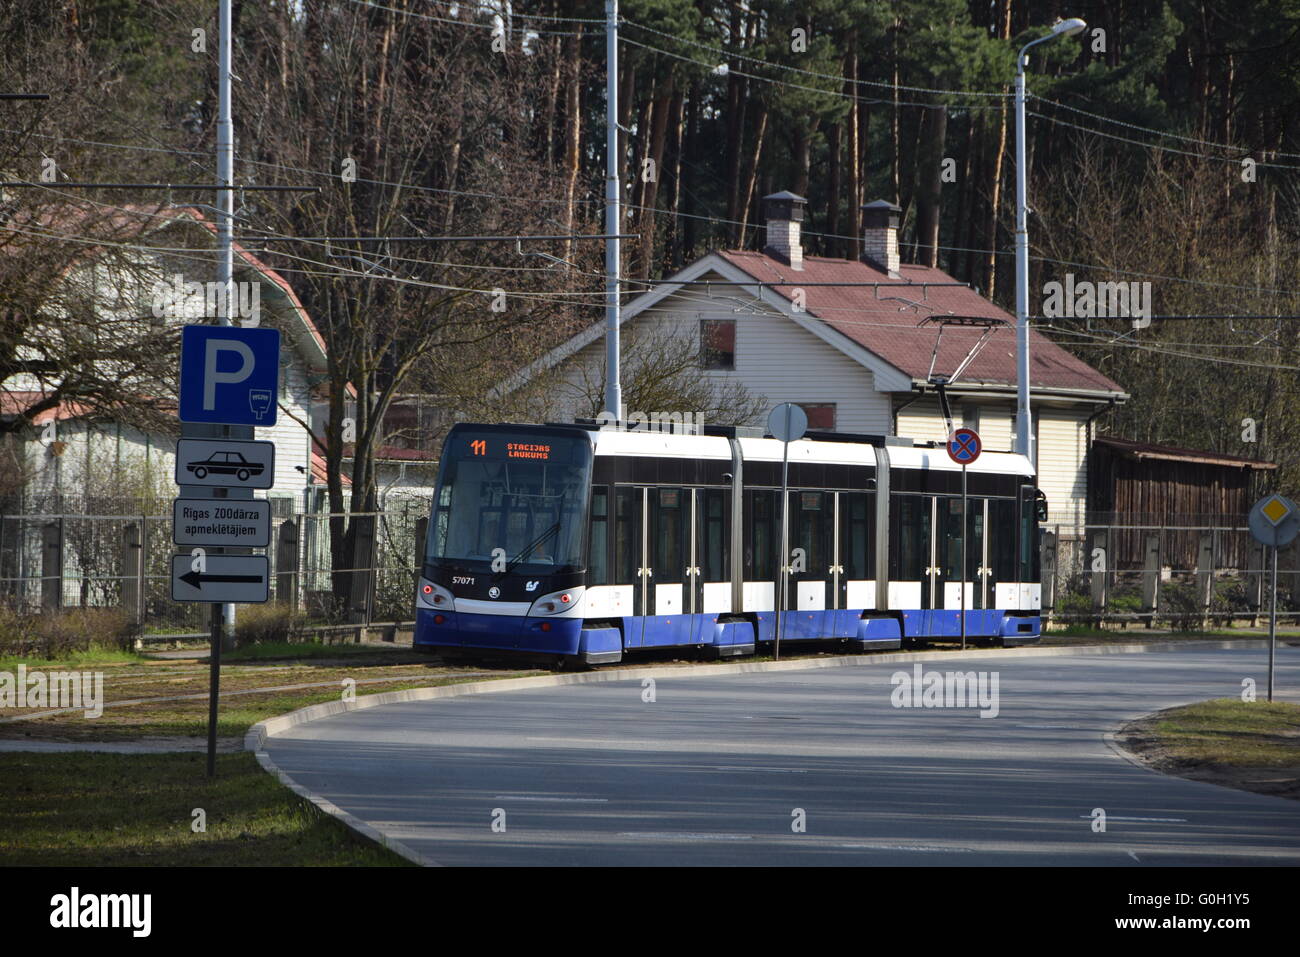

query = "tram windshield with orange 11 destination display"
[[425, 429, 592, 575]]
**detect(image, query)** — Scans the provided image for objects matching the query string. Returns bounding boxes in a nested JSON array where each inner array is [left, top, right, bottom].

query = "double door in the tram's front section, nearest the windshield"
[[641, 486, 693, 648]]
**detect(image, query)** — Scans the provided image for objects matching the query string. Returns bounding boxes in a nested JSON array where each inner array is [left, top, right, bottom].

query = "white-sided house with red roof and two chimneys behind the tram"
[[502, 192, 1128, 527]]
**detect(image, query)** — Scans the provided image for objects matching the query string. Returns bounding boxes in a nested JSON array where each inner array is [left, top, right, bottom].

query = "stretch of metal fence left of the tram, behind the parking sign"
[[0, 495, 430, 635]]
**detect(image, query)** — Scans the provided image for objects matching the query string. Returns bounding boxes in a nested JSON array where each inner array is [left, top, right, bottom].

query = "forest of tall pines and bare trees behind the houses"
[[0, 0, 1300, 512]]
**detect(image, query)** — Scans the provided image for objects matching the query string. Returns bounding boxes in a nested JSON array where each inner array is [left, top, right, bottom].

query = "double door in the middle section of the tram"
[[781, 489, 835, 638]]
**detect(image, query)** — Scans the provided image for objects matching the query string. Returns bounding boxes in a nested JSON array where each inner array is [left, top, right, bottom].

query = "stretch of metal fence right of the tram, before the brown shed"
[[1041, 512, 1300, 628]]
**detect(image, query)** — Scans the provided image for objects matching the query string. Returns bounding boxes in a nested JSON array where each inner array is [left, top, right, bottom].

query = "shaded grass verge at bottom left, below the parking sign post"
[[0, 753, 408, 867]]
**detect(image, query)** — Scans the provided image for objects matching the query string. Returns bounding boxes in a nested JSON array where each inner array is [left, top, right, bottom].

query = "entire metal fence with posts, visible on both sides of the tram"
[[0, 495, 1300, 636]]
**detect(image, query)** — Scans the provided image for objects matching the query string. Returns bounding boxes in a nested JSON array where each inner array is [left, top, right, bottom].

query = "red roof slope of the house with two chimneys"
[[719, 250, 1125, 393]]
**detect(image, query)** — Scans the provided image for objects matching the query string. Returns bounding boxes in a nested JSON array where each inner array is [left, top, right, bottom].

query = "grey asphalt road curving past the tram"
[[265, 646, 1300, 867]]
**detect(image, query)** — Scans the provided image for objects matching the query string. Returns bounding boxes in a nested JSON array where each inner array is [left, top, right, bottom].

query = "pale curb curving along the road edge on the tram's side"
[[243, 638, 1269, 867]]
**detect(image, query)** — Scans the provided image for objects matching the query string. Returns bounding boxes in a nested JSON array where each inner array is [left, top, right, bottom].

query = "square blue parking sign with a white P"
[[179, 325, 280, 425]]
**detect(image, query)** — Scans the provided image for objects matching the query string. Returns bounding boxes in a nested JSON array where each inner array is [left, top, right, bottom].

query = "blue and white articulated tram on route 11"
[[415, 424, 1041, 664]]
